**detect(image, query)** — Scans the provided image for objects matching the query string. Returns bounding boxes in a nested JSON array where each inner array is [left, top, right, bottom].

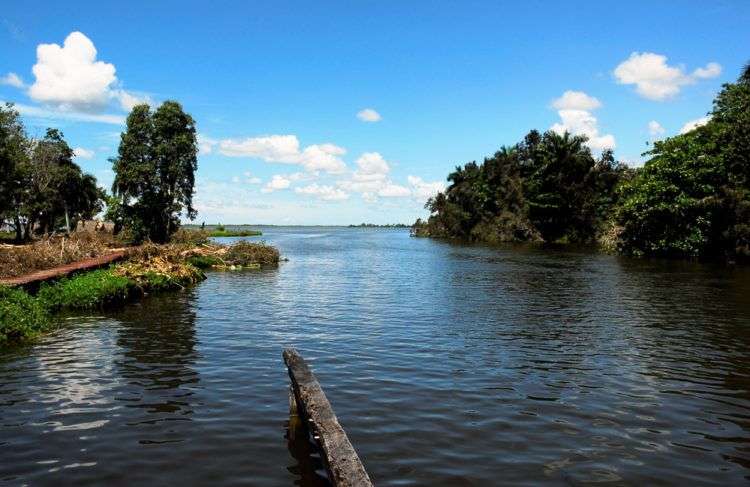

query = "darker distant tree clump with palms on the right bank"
[[414, 131, 627, 242]]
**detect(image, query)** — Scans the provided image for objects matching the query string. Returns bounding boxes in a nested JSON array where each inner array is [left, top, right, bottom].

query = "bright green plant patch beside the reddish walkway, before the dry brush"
[[37, 269, 136, 310]]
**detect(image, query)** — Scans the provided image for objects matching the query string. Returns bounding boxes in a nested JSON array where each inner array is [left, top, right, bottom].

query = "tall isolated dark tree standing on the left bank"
[[112, 101, 198, 242]]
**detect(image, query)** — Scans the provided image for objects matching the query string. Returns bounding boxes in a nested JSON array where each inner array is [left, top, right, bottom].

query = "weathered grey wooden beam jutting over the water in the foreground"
[[284, 348, 373, 487]]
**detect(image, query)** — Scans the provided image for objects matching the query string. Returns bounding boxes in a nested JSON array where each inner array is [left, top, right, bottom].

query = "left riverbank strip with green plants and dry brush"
[[0, 232, 279, 346]]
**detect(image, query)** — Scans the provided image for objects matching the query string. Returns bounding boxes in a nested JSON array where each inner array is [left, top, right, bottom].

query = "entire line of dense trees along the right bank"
[[414, 66, 750, 260]]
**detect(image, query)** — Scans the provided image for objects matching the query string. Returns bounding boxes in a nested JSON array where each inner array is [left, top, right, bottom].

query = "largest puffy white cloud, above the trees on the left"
[[28, 32, 144, 113]]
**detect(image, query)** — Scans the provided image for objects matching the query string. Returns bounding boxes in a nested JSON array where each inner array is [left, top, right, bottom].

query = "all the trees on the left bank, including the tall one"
[[0, 101, 198, 243]]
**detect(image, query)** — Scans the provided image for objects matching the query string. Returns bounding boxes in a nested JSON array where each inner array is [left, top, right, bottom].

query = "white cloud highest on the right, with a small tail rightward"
[[614, 52, 721, 101]]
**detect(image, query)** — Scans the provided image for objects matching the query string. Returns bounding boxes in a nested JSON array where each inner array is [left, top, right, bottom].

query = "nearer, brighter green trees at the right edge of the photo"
[[617, 66, 750, 259]]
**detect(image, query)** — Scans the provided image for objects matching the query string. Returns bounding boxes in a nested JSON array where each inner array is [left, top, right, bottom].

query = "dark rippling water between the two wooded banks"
[[0, 228, 750, 486]]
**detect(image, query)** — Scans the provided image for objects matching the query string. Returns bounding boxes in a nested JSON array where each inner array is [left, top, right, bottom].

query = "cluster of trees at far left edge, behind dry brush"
[[0, 104, 104, 241]]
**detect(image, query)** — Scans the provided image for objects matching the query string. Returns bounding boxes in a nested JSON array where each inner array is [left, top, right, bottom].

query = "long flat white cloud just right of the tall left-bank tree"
[[218, 135, 346, 174]]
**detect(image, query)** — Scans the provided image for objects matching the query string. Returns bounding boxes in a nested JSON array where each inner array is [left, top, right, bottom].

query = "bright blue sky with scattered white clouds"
[[0, 0, 750, 225]]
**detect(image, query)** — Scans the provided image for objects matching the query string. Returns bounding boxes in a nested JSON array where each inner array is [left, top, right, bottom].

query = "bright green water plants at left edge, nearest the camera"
[[0, 286, 52, 346]]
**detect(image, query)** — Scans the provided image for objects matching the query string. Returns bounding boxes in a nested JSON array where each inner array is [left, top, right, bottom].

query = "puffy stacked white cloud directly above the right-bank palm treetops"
[[550, 90, 615, 150]]
